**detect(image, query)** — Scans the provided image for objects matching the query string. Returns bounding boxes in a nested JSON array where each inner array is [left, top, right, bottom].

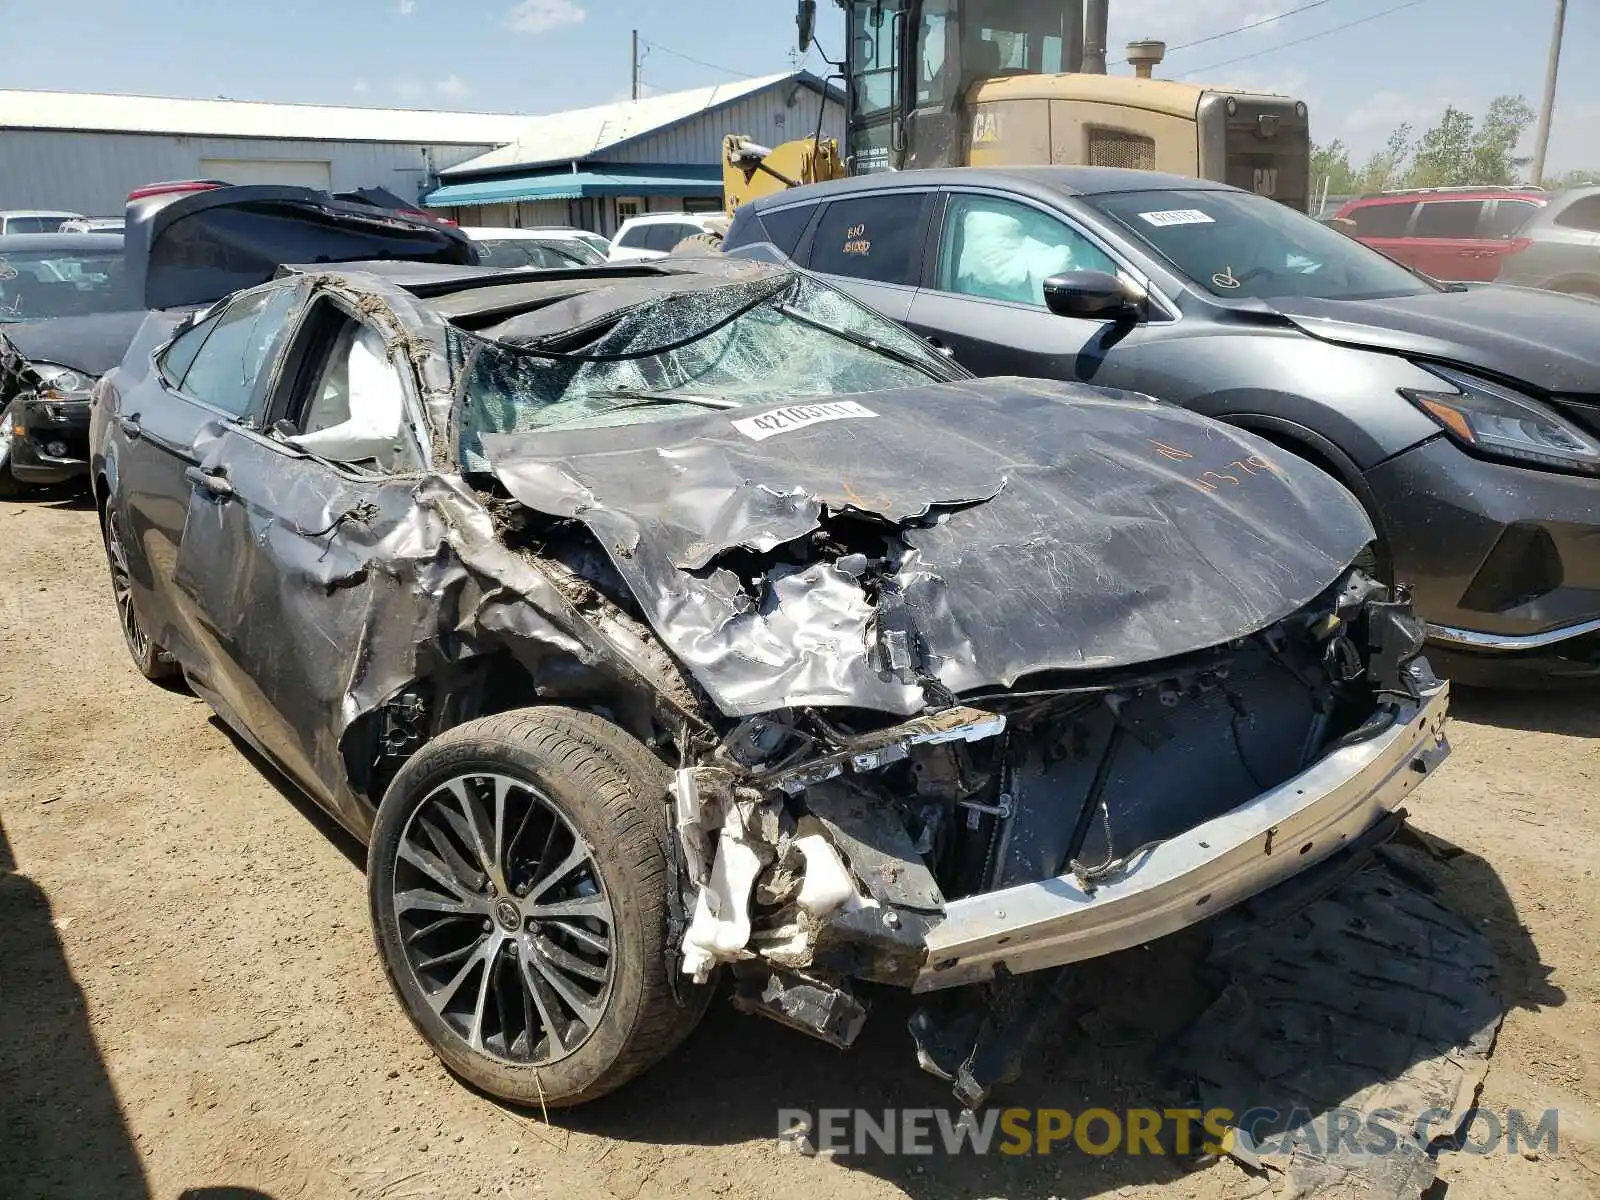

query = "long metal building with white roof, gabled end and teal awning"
[[0, 74, 843, 234]]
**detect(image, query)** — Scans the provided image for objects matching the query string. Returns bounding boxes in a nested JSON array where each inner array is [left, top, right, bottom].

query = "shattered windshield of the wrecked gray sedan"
[[454, 275, 966, 470]]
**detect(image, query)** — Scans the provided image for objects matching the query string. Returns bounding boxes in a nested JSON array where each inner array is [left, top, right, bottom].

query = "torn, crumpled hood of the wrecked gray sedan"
[[483, 379, 1373, 715]]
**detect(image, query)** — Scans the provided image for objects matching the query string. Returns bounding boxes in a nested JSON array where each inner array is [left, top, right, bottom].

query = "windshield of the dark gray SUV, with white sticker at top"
[[1083, 190, 1437, 299]]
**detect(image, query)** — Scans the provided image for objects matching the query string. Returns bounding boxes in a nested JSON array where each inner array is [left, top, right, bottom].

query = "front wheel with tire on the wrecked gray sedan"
[[368, 707, 710, 1107]]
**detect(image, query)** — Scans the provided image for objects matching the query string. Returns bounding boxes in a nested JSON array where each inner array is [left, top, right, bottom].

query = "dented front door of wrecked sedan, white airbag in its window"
[[178, 294, 427, 832]]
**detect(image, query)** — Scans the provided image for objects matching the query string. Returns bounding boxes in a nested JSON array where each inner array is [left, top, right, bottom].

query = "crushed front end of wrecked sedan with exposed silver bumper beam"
[[672, 570, 1448, 1102]]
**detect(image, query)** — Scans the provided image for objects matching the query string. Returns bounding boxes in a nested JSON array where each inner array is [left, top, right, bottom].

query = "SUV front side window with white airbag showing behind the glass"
[[939, 195, 1117, 307]]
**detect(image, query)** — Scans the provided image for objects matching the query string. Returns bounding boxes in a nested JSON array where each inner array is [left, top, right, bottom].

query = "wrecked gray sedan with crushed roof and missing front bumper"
[[93, 258, 1446, 1106]]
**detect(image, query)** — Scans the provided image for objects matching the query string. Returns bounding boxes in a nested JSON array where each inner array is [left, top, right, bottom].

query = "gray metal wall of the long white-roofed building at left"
[[0, 128, 494, 216]]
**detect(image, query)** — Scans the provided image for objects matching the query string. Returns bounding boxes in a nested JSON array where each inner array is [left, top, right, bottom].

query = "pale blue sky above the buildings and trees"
[[0, 0, 1600, 170]]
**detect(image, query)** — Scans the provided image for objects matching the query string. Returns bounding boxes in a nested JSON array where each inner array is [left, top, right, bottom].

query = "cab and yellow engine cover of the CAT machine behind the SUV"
[[838, 0, 1310, 210]]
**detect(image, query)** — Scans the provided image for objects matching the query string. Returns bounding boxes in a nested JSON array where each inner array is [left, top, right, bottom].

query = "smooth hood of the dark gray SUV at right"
[[1267, 285, 1600, 394]]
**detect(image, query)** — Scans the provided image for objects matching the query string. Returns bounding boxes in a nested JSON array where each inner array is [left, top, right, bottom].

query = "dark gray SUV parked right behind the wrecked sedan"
[[726, 166, 1600, 683]]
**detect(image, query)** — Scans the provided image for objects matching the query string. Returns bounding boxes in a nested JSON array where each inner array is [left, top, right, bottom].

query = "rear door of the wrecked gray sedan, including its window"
[[104, 283, 296, 670]]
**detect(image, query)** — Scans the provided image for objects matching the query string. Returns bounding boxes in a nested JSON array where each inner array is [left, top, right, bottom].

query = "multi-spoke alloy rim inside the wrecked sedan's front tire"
[[392, 771, 616, 1066]]
